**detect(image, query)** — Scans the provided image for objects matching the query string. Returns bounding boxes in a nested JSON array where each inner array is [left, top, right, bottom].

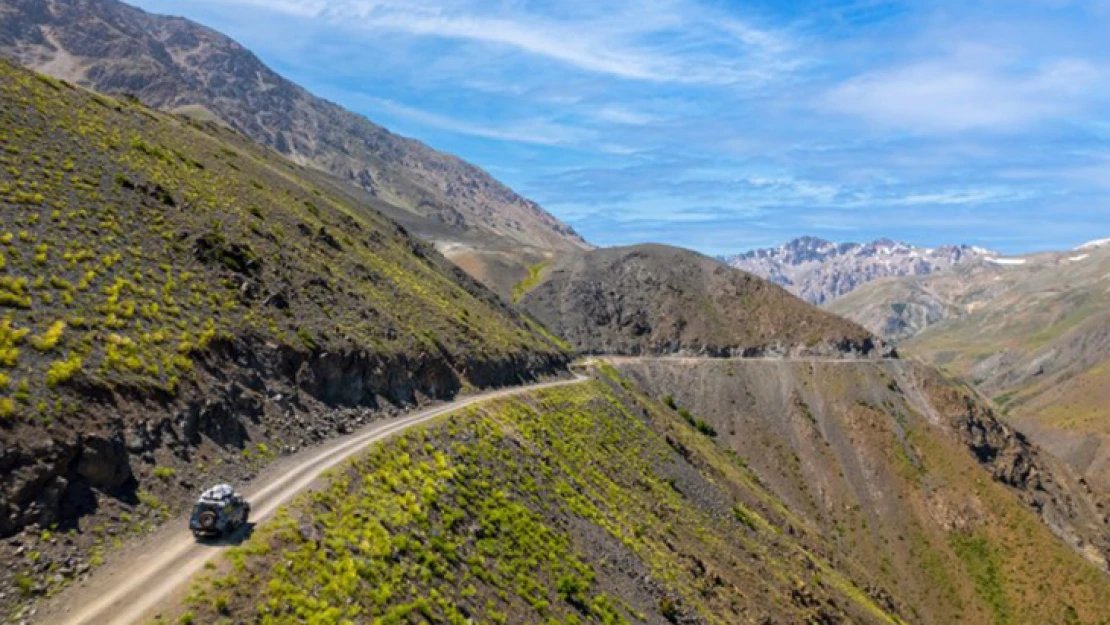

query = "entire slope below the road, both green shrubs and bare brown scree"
[[173, 360, 1110, 625]]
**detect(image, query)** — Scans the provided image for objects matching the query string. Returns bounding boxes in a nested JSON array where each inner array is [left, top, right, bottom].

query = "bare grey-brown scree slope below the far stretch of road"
[[615, 359, 1110, 624]]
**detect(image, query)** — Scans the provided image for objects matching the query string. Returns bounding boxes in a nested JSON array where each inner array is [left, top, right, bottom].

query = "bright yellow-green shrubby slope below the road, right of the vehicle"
[[186, 383, 900, 624]]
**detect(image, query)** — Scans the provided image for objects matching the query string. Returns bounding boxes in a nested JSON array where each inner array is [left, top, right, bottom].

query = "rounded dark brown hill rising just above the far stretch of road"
[[519, 245, 884, 356]]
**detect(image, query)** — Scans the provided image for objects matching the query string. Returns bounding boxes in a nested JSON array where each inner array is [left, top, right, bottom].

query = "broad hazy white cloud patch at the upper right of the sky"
[[821, 54, 1103, 132]]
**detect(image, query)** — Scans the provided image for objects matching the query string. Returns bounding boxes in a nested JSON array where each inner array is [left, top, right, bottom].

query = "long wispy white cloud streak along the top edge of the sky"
[[195, 0, 797, 84]]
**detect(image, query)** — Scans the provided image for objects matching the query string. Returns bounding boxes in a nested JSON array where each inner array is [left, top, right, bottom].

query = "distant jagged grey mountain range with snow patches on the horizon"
[[723, 236, 990, 305]]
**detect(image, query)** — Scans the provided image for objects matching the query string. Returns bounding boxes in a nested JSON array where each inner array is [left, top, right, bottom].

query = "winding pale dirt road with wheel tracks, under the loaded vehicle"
[[37, 375, 588, 625]]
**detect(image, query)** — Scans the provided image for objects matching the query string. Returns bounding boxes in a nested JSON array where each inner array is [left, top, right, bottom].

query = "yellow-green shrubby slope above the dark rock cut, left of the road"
[[0, 61, 562, 421]]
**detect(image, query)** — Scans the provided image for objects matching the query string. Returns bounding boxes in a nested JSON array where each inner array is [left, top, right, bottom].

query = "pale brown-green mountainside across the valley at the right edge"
[[829, 244, 1110, 495]]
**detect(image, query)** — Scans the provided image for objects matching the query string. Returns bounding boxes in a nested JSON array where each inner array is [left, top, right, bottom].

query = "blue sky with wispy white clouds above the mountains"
[[129, 0, 1110, 254]]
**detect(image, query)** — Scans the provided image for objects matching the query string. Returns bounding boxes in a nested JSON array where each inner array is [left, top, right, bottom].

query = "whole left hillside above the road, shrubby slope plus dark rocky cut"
[[0, 56, 566, 598]]
